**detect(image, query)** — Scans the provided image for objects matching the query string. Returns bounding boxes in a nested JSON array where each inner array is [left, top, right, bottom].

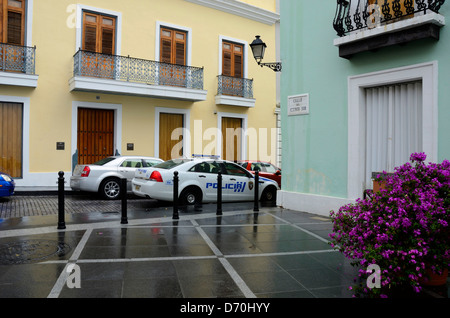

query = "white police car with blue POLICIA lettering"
[[132, 159, 279, 205]]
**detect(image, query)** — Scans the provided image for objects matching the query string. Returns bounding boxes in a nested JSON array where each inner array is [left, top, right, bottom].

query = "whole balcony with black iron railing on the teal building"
[[333, 0, 445, 59]]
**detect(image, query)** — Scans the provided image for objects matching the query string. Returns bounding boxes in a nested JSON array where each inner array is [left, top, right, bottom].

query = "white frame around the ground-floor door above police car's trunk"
[[154, 107, 191, 158]]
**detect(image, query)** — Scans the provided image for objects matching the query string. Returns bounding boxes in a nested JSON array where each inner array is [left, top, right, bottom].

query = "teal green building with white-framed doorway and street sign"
[[277, 0, 450, 215]]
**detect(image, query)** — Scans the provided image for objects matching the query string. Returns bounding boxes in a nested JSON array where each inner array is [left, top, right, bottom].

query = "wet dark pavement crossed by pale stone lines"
[[0, 196, 446, 306]]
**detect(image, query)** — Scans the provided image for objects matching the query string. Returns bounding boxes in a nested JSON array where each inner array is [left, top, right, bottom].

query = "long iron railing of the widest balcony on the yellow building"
[[73, 50, 203, 90]]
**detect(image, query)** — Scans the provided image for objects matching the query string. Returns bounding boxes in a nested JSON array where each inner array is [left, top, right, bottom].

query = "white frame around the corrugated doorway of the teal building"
[[347, 61, 438, 200]]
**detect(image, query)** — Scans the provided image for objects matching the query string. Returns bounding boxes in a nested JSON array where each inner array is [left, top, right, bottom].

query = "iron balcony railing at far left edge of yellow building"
[[0, 43, 36, 75]]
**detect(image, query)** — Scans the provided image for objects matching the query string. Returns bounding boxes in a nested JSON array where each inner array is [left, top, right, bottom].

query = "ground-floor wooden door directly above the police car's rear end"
[[159, 113, 184, 160]]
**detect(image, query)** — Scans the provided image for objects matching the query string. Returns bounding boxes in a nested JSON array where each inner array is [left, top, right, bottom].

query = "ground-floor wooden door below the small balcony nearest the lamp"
[[222, 117, 242, 161]]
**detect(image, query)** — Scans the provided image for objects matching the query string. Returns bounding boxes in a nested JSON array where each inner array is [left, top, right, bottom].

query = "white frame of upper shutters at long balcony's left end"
[[75, 4, 122, 55]]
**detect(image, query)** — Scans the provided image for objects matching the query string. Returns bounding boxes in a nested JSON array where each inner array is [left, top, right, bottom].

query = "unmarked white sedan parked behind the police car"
[[70, 156, 163, 200]]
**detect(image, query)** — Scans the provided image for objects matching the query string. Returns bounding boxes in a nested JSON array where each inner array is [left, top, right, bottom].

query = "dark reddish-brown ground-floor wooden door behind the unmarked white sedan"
[[77, 108, 114, 164]]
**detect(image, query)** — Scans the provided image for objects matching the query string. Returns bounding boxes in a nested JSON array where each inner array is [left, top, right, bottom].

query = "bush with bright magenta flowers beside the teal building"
[[330, 153, 450, 297]]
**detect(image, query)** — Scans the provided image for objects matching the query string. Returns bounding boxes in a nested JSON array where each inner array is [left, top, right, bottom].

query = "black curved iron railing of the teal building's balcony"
[[333, 0, 445, 37]]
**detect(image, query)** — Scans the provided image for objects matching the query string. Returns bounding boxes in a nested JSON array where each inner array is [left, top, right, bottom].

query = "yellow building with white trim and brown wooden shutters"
[[0, 0, 279, 189]]
